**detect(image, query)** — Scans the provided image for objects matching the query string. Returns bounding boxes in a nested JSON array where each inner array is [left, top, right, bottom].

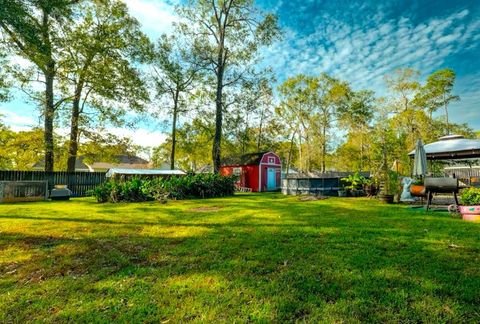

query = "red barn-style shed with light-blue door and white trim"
[[220, 152, 282, 192]]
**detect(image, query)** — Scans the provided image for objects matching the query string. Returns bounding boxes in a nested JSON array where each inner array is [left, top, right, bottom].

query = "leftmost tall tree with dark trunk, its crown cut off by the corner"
[[0, 0, 80, 171]]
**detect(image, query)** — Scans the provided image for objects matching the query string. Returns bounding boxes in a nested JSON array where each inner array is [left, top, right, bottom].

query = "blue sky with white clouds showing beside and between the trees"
[[0, 0, 480, 149]]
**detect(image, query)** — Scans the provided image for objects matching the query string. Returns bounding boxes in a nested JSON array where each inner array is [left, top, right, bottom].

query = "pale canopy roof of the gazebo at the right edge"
[[408, 135, 480, 159]]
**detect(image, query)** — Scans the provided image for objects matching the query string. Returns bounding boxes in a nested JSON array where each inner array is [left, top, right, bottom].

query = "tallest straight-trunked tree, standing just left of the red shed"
[[179, 0, 279, 172]]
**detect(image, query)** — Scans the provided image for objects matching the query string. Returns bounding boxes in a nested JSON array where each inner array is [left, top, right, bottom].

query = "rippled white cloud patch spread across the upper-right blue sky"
[[266, 10, 480, 94]]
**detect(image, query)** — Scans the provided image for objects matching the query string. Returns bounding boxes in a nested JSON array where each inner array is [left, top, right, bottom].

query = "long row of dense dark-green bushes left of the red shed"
[[91, 174, 237, 202]]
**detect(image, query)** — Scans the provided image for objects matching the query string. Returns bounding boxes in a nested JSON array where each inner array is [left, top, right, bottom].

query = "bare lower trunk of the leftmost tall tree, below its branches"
[[44, 62, 55, 172]]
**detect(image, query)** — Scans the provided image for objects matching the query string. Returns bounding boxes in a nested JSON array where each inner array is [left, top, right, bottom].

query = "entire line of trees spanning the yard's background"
[[0, 0, 475, 177]]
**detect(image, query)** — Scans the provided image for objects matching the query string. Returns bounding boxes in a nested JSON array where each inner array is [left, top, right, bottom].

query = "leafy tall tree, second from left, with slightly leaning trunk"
[[59, 0, 151, 172]]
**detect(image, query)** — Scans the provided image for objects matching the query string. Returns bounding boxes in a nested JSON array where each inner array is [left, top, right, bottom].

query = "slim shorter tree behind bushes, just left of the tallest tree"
[[152, 35, 200, 170]]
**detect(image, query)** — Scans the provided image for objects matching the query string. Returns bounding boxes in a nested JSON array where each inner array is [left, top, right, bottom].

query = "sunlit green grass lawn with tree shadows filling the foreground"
[[0, 194, 480, 323]]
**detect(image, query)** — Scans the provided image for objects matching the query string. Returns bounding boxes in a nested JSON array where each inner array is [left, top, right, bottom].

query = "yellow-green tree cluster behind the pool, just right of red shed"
[[275, 73, 354, 172]]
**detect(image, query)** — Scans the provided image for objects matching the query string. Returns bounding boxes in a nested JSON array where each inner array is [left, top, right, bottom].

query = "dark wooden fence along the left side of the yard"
[[0, 170, 105, 197]]
